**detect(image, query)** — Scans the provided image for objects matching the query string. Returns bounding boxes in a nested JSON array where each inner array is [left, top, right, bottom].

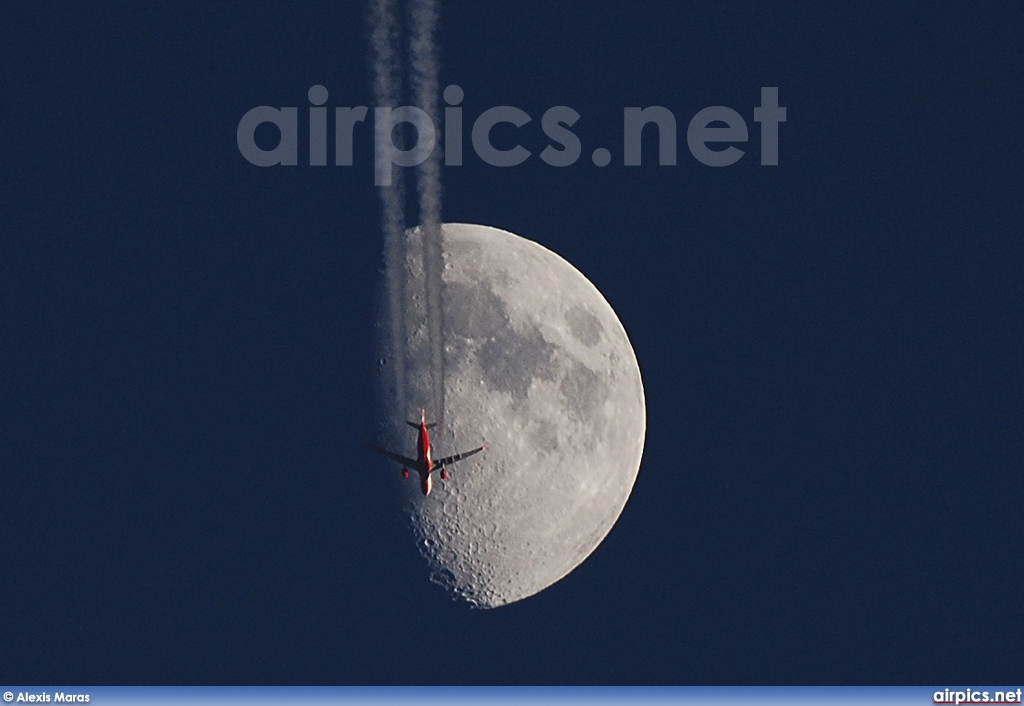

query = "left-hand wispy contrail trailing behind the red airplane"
[[370, 0, 407, 414]]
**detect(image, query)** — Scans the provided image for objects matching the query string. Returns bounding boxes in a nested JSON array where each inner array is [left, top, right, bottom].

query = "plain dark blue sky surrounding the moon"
[[0, 1, 1024, 684]]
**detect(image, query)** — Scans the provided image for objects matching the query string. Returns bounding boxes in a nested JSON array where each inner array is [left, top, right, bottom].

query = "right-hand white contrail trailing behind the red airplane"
[[410, 0, 444, 422]]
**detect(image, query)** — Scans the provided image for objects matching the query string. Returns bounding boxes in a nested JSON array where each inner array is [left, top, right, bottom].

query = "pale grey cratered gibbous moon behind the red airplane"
[[378, 223, 646, 608]]
